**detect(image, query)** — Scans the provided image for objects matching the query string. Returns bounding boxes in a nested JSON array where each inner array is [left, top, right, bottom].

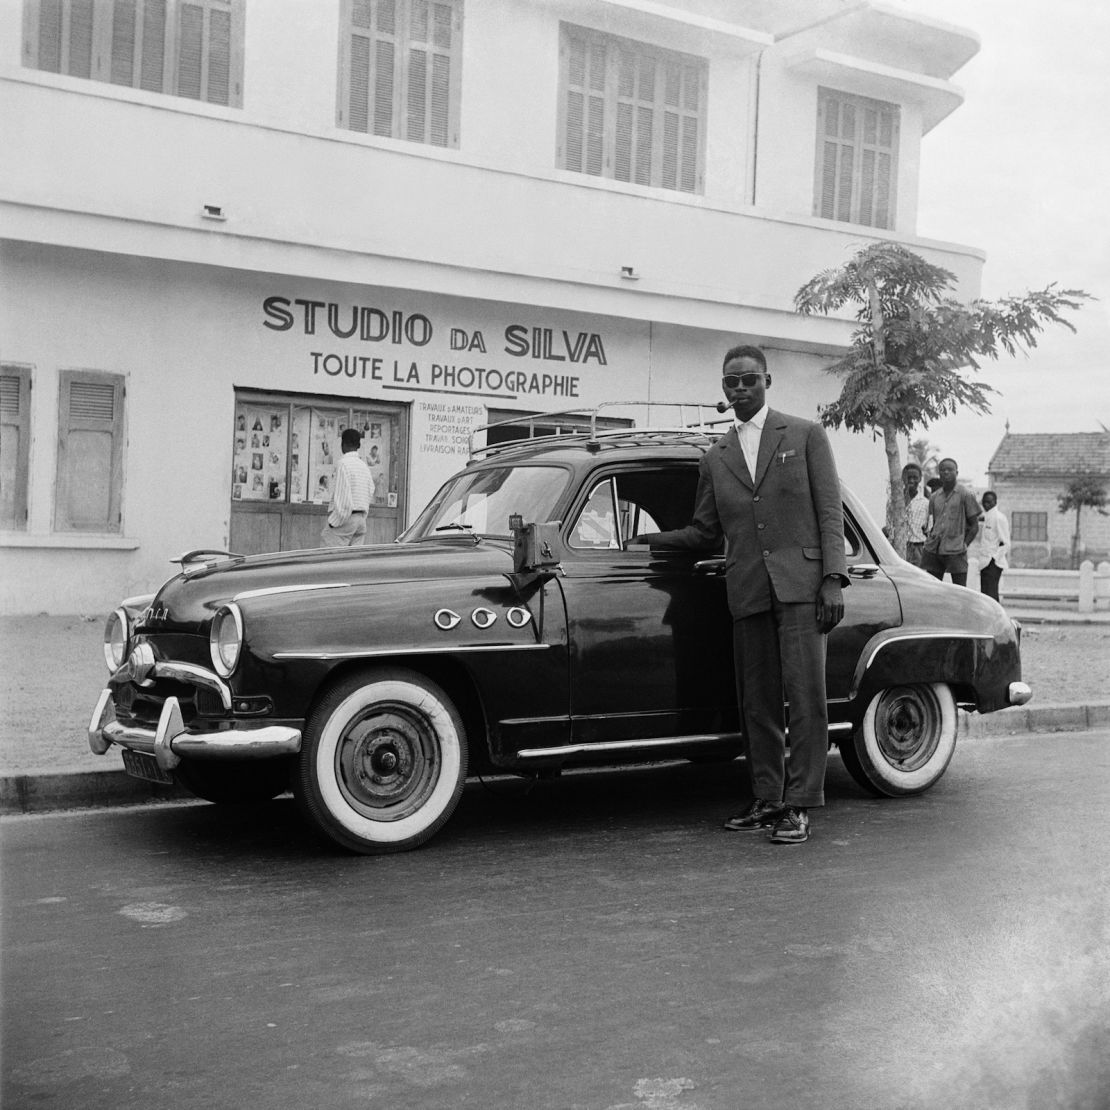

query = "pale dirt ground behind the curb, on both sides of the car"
[[0, 615, 1110, 775]]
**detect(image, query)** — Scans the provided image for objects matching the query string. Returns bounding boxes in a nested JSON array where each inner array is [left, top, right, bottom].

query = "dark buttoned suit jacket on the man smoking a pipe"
[[647, 410, 848, 618]]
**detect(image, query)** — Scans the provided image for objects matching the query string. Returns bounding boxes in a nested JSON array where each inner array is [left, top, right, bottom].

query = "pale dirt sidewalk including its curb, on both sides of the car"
[[0, 605, 1110, 814]]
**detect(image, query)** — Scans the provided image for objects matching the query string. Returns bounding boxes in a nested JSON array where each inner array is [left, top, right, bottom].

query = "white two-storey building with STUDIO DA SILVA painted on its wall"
[[0, 0, 982, 613]]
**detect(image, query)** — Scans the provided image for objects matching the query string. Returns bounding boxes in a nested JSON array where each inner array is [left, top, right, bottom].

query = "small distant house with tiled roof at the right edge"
[[987, 431, 1110, 567]]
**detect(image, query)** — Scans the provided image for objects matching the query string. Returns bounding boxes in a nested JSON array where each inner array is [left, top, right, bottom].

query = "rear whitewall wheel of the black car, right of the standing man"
[[840, 683, 957, 797]]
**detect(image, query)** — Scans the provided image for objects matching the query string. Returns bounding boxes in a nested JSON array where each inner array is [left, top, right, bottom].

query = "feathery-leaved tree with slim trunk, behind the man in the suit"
[[794, 242, 1091, 554]]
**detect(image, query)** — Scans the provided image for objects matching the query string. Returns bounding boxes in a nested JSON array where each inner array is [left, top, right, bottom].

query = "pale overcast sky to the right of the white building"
[[897, 0, 1110, 485]]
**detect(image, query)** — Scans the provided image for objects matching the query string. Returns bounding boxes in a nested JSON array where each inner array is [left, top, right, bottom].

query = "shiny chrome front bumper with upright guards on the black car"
[[89, 689, 301, 771]]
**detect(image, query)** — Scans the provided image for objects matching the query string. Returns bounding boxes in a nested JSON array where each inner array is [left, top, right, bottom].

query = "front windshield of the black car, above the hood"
[[402, 466, 569, 543]]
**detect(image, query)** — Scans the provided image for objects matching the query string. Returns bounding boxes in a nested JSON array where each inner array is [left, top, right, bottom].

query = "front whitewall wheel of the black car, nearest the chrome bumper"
[[295, 668, 466, 854]]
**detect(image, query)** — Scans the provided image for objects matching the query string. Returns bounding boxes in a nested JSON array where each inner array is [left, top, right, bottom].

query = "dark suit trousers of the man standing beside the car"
[[733, 591, 829, 807]]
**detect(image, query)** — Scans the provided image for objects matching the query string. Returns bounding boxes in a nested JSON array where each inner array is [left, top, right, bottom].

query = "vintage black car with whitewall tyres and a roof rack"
[[89, 418, 1030, 852]]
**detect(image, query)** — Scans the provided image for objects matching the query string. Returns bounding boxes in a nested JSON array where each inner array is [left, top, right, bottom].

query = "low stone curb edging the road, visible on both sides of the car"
[[0, 702, 1110, 816]]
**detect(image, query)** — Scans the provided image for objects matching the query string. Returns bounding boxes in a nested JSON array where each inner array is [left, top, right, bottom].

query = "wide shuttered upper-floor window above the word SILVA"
[[557, 23, 708, 193]]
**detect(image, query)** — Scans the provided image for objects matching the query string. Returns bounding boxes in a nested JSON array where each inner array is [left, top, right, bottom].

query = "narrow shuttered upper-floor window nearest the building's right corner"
[[814, 89, 899, 228]]
